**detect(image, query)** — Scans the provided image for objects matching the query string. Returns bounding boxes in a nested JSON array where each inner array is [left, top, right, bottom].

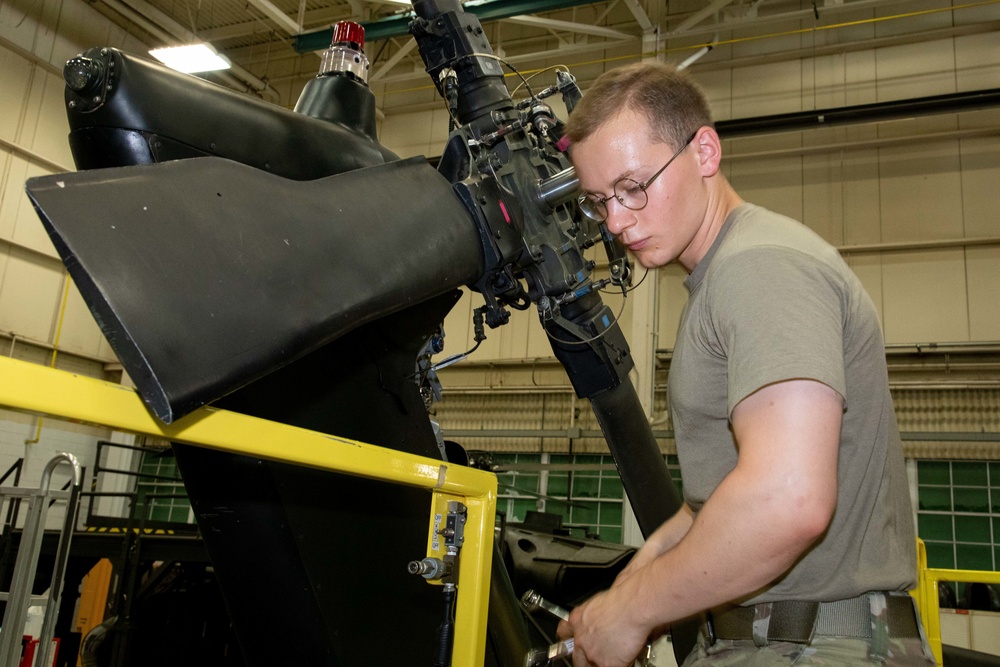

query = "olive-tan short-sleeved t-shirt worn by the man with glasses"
[[669, 204, 916, 603]]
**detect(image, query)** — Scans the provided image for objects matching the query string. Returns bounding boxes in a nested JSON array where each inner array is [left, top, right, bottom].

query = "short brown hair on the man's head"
[[566, 61, 714, 147]]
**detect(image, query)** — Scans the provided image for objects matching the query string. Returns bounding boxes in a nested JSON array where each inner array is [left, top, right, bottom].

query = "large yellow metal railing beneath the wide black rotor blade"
[[0, 357, 497, 667]]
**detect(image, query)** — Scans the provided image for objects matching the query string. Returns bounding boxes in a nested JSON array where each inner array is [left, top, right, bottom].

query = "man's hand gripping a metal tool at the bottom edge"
[[558, 589, 648, 667]]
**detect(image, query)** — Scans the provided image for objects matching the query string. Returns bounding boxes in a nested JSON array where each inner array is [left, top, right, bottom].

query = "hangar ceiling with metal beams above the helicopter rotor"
[[93, 0, 1000, 105]]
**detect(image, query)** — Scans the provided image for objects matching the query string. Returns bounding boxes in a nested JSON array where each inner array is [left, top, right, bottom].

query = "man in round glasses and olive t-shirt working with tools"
[[560, 63, 931, 667]]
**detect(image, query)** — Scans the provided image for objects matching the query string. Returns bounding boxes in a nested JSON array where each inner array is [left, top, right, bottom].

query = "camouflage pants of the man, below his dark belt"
[[683, 637, 934, 667]]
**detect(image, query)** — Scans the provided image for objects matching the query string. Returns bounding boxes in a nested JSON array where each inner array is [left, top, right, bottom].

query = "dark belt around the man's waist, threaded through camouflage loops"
[[706, 593, 920, 644]]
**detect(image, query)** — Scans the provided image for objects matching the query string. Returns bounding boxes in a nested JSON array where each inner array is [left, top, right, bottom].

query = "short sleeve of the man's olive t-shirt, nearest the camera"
[[709, 246, 847, 416]]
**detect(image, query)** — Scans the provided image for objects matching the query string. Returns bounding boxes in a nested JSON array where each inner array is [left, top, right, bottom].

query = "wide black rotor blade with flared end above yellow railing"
[[27, 158, 483, 423]]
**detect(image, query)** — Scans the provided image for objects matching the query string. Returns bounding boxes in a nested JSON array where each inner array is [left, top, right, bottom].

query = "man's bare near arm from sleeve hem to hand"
[[563, 380, 843, 667]]
